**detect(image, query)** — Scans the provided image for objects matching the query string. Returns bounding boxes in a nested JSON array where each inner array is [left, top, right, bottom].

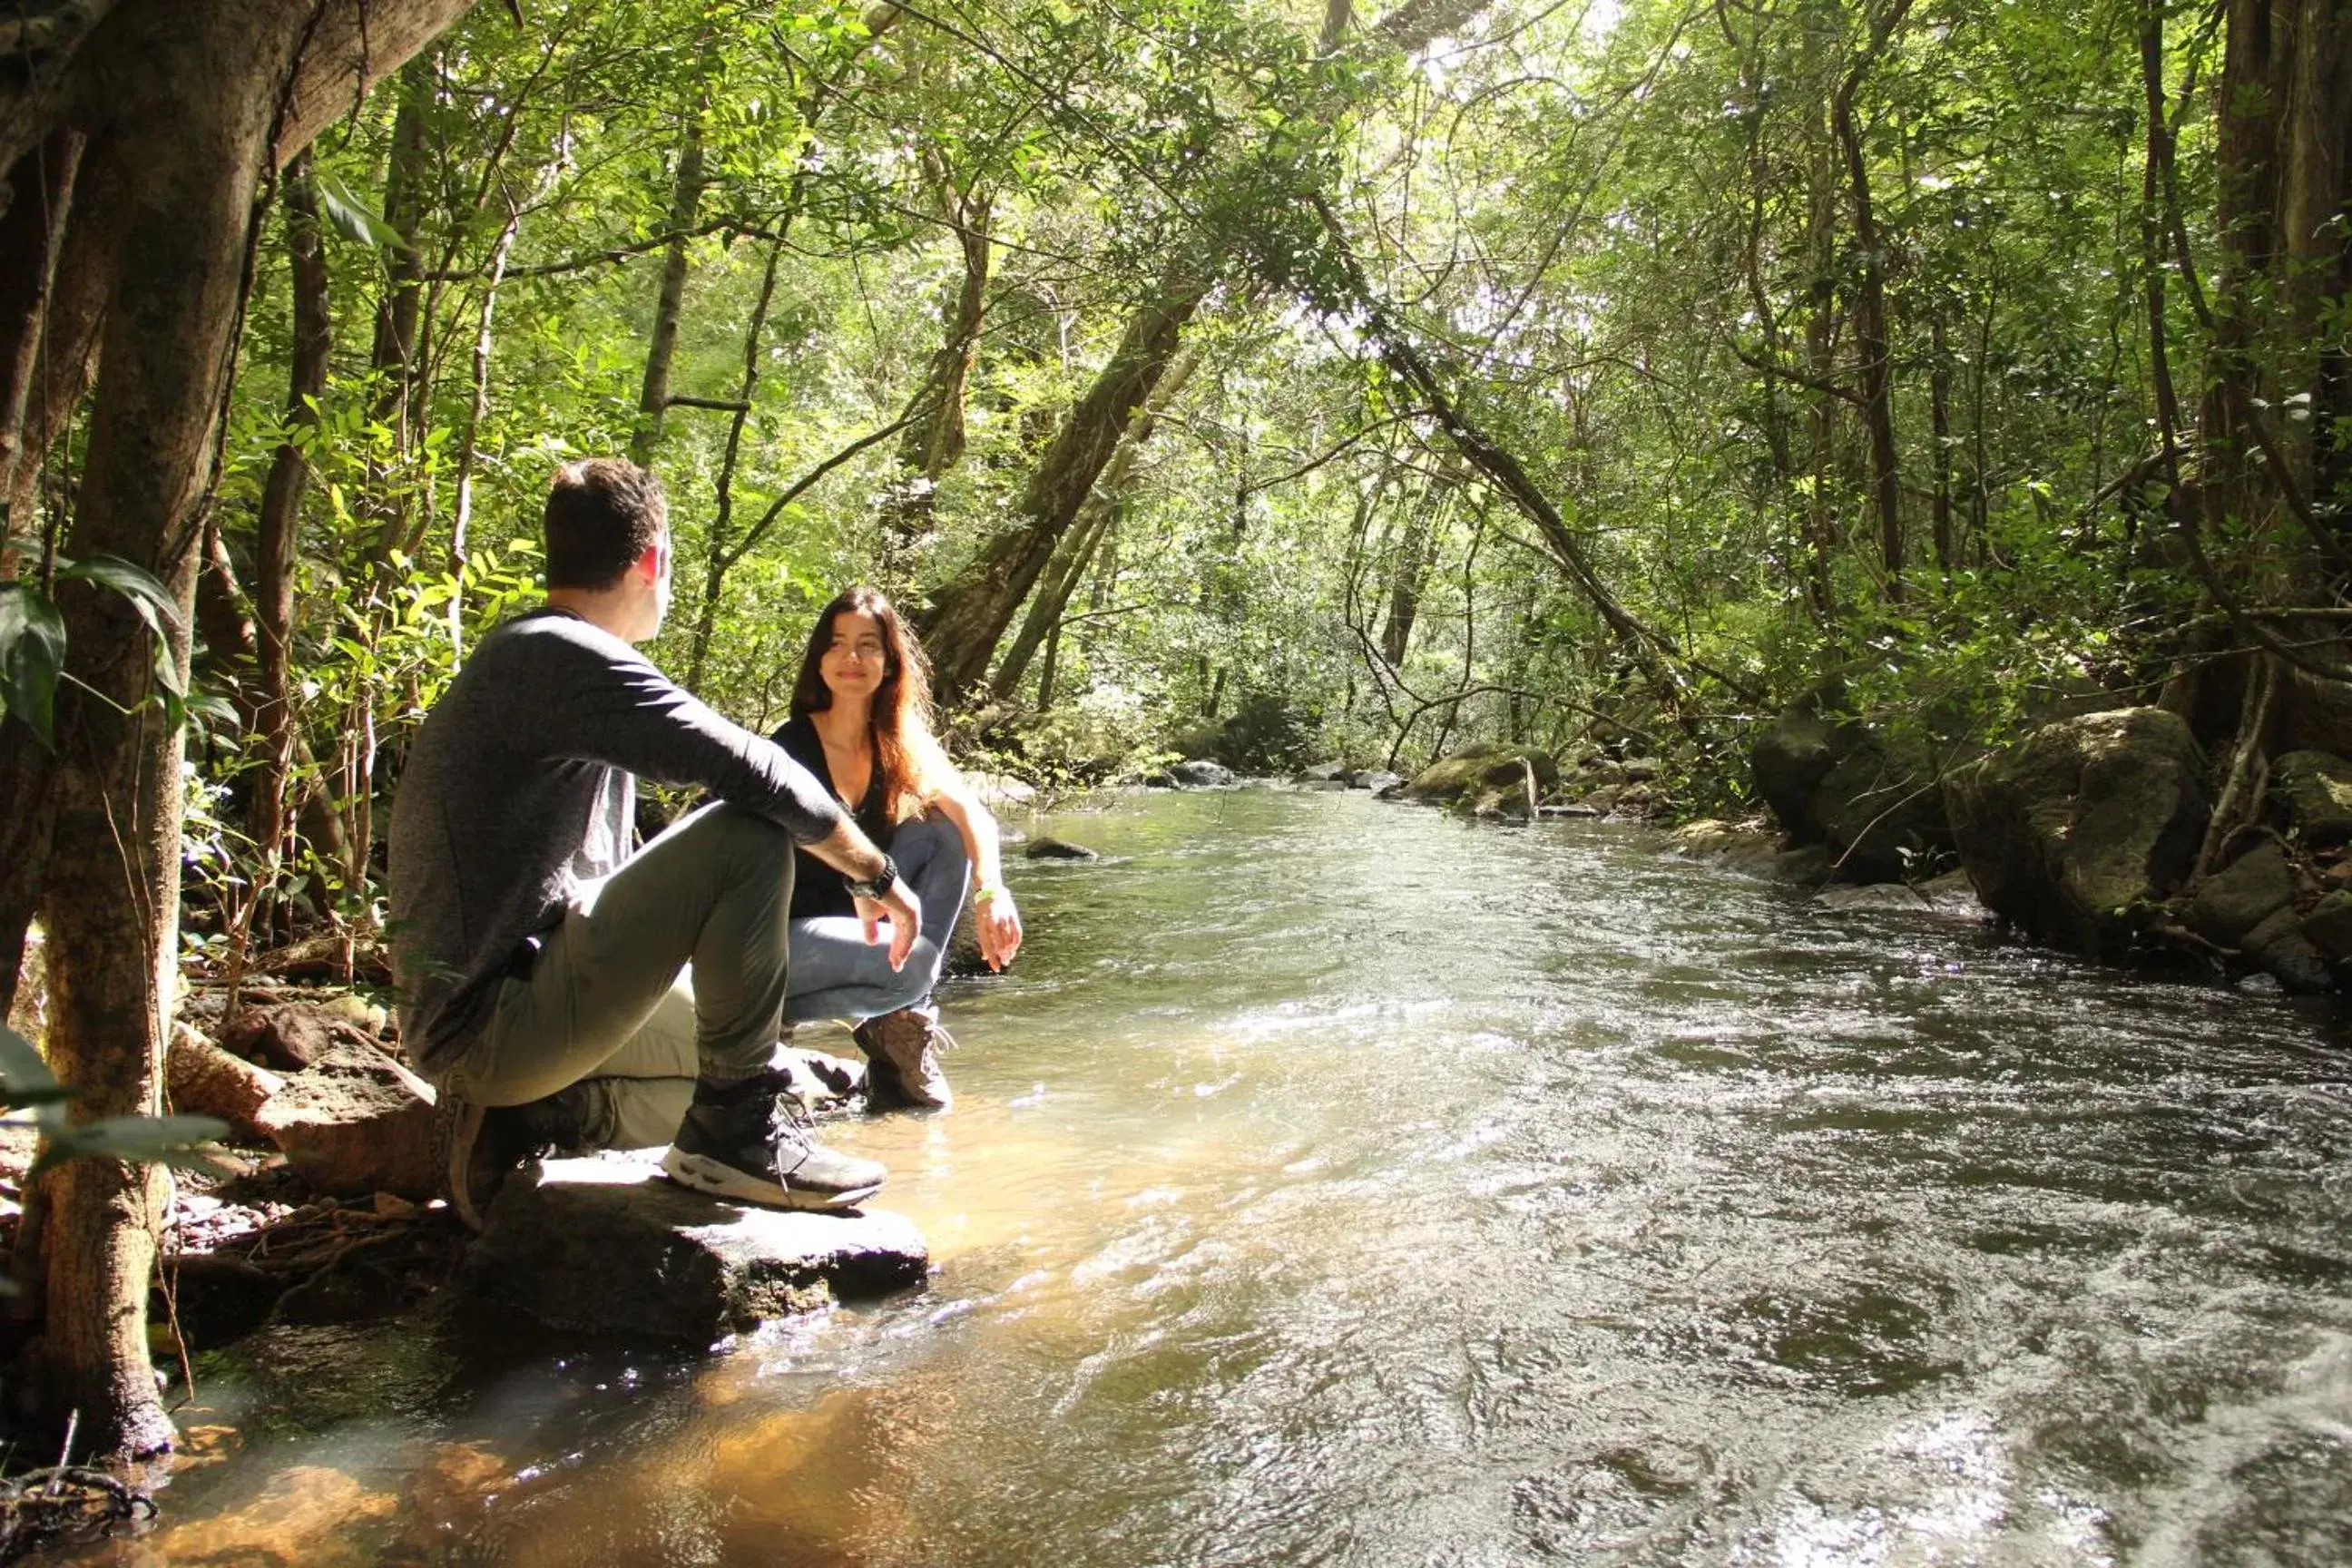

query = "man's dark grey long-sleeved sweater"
[[390, 609, 842, 1077]]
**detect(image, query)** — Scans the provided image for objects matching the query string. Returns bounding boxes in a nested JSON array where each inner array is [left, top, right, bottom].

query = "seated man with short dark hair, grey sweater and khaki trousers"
[[390, 458, 922, 1222]]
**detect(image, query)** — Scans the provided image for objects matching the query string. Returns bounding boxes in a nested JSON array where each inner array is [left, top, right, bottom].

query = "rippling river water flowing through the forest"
[[64, 792, 2352, 1568]]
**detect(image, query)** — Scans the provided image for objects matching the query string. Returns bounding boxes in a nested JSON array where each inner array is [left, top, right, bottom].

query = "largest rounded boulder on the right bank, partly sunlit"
[[1945, 708, 2210, 959]]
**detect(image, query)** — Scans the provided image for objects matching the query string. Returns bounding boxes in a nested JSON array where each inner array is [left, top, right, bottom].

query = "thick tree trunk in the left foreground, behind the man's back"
[[11, 0, 464, 1453]]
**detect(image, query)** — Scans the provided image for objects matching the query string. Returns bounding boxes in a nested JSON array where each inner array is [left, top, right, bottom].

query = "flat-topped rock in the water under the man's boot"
[[468, 1154, 931, 1345]]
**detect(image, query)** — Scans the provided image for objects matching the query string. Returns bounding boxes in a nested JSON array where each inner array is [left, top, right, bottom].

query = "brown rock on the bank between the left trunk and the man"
[[251, 1042, 440, 1201]]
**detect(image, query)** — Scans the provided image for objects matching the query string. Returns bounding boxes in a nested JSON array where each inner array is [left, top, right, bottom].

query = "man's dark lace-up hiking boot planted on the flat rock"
[[661, 1072, 889, 1209]]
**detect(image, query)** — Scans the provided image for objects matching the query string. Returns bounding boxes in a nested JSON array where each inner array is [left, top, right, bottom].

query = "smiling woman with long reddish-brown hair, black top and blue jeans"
[[774, 588, 1021, 1110]]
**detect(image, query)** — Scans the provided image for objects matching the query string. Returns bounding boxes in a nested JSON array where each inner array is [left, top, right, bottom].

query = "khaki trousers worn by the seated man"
[[445, 807, 793, 1147]]
